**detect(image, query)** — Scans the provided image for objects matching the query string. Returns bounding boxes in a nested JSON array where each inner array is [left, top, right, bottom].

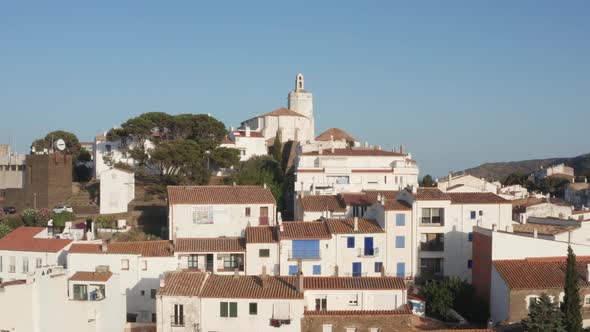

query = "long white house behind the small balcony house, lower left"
[[68, 241, 179, 323]]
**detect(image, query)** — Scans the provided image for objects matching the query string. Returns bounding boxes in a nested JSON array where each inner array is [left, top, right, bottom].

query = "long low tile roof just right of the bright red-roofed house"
[[68, 240, 174, 257]]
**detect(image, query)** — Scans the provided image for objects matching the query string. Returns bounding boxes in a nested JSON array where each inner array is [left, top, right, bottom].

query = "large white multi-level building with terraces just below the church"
[[295, 147, 418, 195]]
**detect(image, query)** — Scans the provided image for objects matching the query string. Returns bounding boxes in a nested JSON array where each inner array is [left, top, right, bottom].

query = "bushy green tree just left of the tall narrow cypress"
[[523, 293, 569, 332]]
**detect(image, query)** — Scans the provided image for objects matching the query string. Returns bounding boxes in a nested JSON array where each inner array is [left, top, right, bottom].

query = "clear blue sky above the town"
[[0, 0, 590, 176]]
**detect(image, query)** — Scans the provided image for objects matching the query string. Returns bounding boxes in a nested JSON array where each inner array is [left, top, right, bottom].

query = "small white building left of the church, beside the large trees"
[[220, 126, 268, 161]]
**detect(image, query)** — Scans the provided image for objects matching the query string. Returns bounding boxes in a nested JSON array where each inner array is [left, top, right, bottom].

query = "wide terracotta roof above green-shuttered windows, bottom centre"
[[200, 274, 303, 299]]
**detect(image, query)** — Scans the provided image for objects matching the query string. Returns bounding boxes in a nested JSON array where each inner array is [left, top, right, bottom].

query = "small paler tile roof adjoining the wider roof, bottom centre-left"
[[158, 271, 207, 296]]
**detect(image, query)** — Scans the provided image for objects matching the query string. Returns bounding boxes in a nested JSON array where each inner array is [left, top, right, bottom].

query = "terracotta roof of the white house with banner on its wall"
[[168, 186, 276, 204]]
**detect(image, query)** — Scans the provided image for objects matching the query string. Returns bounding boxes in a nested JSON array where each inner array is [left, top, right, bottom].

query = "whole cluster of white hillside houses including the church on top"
[[0, 74, 590, 332]]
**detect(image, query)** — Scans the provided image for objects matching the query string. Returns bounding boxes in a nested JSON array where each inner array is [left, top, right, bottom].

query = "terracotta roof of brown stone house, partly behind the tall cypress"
[[494, 256, 590, 290]]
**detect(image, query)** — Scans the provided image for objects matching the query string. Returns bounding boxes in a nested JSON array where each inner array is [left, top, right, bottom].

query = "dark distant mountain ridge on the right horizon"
[[463, 153, 590, 181]]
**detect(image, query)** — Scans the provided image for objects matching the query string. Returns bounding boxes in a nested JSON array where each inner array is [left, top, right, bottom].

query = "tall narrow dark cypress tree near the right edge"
[[561, 246, 584, 332]]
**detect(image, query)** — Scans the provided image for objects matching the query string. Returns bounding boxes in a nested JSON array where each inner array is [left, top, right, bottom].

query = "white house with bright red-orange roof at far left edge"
[[0, 226, 72, 281]]
